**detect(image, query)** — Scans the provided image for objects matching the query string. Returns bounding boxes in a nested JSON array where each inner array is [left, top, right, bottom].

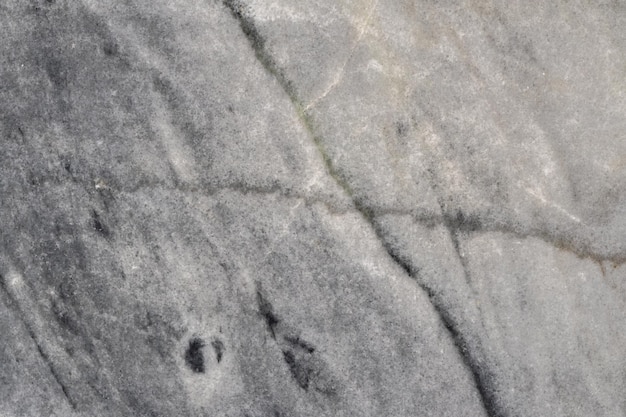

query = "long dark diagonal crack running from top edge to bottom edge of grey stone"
[[223, 0, 505, 417]]
